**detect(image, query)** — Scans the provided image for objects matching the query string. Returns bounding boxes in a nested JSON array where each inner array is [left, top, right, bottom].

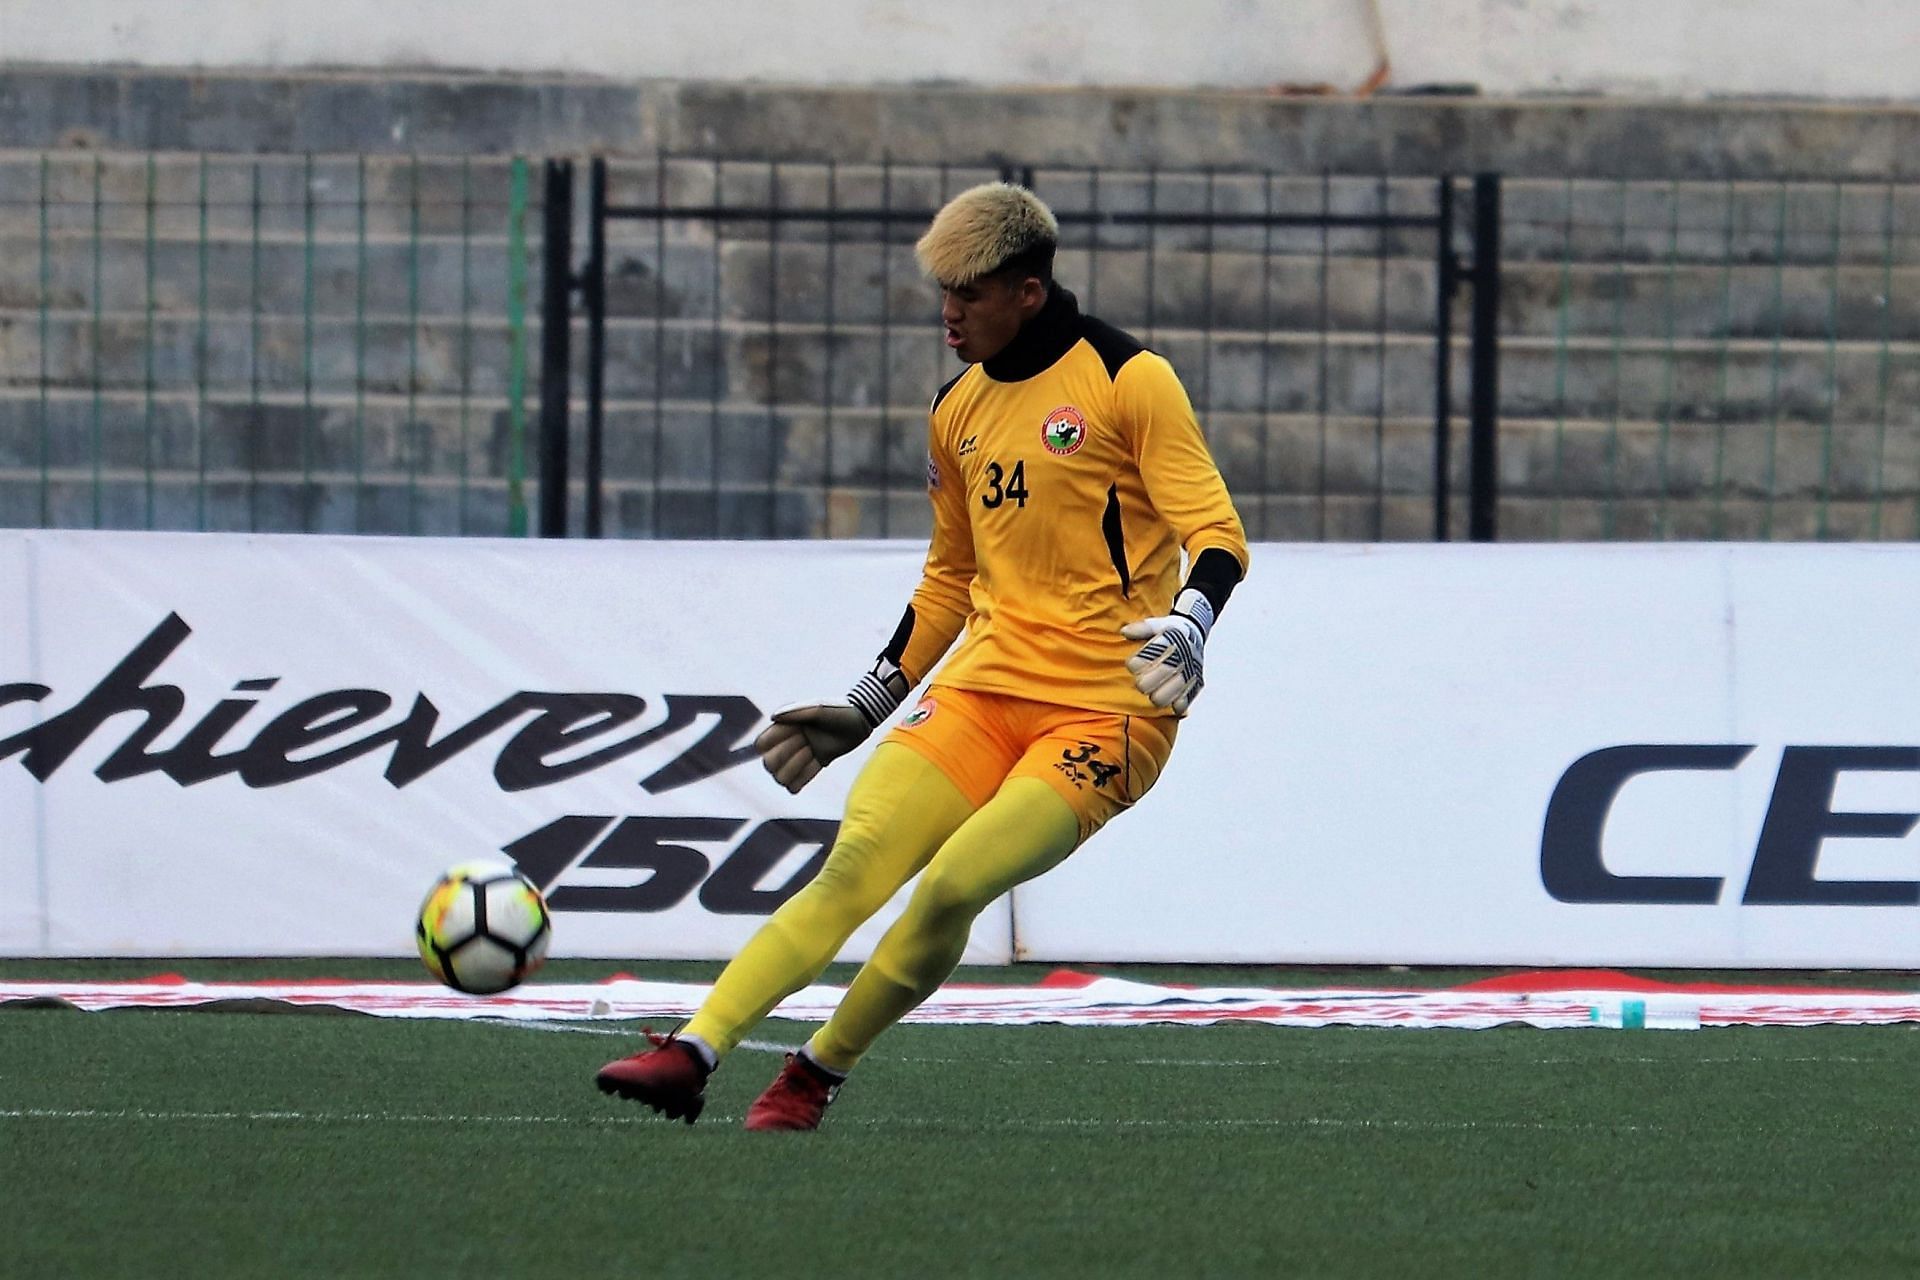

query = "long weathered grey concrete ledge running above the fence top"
[[0, 68, 1920, 180]]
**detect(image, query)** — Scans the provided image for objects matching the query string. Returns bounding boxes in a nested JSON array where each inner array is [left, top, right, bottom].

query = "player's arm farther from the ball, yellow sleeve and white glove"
[[1114, 351, 1248, 714]]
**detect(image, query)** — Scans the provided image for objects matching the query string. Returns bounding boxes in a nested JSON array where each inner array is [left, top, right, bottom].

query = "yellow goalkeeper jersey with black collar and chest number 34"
[[895, 286, 1246, 716]]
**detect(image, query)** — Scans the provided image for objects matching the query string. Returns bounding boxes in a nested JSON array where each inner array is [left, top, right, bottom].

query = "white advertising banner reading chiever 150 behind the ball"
[[0, 533, 1012, 963]]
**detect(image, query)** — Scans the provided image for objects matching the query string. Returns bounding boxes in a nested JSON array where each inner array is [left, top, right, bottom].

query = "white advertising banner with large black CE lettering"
[[1016, 545, 1920, 967]]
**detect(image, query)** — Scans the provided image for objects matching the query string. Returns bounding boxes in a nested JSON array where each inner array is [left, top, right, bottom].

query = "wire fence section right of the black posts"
[[1501, 180, 1920, 539]]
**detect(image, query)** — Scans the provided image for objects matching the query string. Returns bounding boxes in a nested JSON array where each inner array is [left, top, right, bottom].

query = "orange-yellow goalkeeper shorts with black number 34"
[[887, 685, 1179, 841]]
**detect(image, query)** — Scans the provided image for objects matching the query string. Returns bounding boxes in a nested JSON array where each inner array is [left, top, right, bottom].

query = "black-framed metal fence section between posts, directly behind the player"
[[540, 155, 1498, 539]]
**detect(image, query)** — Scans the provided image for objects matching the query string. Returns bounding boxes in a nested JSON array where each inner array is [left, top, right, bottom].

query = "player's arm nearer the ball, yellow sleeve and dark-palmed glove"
[[753, 401, 973, 793]]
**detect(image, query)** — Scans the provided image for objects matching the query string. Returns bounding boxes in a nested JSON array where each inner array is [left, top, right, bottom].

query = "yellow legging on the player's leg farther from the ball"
[[808, 777, 1079, 1071]]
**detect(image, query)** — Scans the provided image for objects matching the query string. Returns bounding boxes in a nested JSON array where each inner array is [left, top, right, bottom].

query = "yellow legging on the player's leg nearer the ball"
[[685, 743, 973, 1057]]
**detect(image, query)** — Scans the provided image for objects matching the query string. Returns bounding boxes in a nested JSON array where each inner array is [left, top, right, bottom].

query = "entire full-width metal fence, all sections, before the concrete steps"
[[0, 152, 1920, 539]]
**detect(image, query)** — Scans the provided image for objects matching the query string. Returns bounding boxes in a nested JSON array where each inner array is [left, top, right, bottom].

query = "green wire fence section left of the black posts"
[[0, 152, 532, 533]]
